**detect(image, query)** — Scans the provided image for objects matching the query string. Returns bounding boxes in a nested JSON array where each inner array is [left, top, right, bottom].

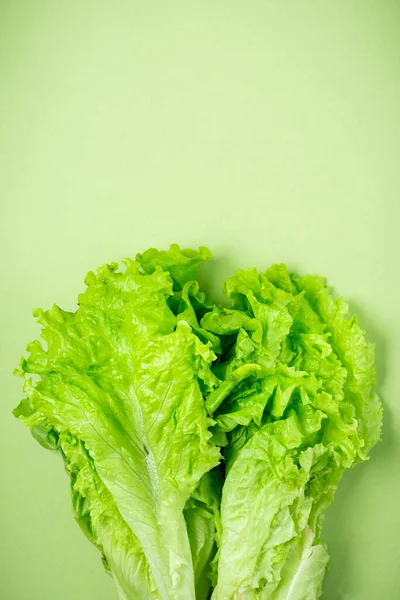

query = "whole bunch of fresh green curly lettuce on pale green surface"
[[14, 245, 382, 600]]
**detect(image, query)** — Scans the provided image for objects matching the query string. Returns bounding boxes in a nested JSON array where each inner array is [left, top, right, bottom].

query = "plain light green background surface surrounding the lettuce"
[[0, 0, 400, 600]]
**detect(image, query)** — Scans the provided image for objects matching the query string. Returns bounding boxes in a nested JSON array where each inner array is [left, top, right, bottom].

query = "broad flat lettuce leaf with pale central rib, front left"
[[16, 254, 219, 599]]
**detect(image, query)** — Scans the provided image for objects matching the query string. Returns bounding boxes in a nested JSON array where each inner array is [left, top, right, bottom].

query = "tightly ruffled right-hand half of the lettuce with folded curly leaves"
[[208, 265, 381, 600]]
